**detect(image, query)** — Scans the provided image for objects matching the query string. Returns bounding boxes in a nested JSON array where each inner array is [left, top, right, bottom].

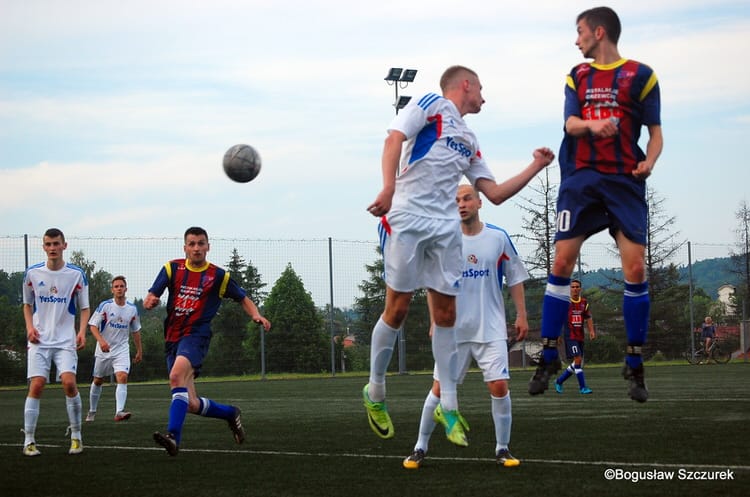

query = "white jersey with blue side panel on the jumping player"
[[388, 93, 494, 219]]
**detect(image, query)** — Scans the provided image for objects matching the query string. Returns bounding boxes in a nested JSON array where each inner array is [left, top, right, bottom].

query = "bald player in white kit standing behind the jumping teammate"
[[403, 185, 529, 469]]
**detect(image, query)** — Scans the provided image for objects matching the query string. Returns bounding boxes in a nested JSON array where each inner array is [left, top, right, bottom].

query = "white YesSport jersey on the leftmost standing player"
[[23, 262, 89, 350]]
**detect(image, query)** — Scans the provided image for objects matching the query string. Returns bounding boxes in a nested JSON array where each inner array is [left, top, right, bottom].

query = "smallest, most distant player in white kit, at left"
[[86, 276, 143, 421]]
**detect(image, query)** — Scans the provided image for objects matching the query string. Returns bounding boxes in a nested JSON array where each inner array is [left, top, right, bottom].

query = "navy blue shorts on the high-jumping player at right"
[[555, 168, 648, 245]]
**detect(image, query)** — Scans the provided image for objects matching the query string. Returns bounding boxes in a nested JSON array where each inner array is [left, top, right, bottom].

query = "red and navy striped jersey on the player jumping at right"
[[560, 59, 661, 177]]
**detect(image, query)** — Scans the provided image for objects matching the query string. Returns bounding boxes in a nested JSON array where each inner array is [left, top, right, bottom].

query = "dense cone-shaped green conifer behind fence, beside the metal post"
[[250, 263, 331, 373]]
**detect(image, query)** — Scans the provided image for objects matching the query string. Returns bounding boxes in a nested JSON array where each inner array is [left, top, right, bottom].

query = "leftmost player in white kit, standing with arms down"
[[23, 228, 90, 456]]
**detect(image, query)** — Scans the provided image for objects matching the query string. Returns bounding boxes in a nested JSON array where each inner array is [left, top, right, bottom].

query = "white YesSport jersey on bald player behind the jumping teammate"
[[456, 223, 529, 343]]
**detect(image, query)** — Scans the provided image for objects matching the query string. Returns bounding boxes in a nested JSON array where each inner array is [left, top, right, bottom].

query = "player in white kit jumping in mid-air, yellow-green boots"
[[362, 66, 555, 446]]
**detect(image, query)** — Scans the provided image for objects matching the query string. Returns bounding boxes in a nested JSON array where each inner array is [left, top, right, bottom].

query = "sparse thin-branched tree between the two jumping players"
[[516, 169, 557, 276]]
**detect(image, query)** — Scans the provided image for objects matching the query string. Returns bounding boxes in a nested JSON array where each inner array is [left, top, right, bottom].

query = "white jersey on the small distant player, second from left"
[[89, 299, 141, 357]]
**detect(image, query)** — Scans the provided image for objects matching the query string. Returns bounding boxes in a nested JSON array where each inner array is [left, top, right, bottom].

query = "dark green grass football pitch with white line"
[[0, 363, 750, 497]]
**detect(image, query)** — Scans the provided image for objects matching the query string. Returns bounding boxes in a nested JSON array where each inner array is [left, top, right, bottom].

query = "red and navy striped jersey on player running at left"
[[148, 259, 245, 342]]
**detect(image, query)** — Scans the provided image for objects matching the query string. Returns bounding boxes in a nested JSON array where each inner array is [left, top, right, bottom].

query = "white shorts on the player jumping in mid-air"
[[381, 212, 463, 295]]
